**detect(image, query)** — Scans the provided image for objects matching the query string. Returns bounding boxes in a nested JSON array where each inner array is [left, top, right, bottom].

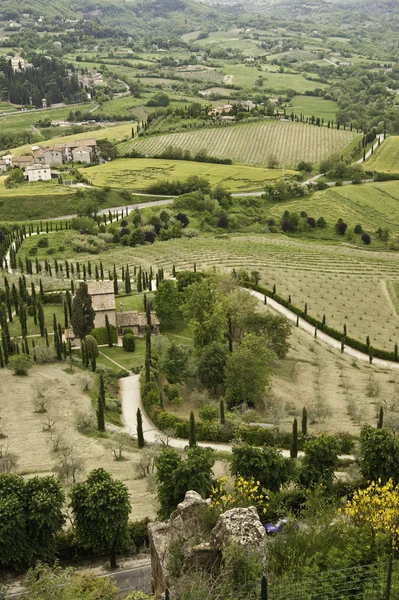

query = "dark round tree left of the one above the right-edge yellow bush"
[[300, 434, 339, 488]]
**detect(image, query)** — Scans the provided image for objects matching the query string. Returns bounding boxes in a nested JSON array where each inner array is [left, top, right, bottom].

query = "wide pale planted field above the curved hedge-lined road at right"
[[47, 234, 399, 350]]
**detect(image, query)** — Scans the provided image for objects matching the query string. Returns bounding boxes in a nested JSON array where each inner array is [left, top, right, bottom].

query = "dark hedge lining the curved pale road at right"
[[243, 282, 398, 362]]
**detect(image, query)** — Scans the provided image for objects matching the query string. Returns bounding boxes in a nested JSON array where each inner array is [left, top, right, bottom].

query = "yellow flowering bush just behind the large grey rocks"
[[211, 475, 269, 513]]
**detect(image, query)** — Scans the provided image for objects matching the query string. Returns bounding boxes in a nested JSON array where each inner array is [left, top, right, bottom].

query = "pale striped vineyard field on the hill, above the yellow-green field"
[[118, 120, 357, 167]]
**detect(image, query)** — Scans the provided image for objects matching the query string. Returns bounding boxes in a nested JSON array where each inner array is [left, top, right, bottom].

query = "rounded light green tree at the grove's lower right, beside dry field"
[[226, 333, 274, 407]]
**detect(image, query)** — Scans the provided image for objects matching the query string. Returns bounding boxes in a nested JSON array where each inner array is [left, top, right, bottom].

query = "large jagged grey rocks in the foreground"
[[148, 491, 266, 598]]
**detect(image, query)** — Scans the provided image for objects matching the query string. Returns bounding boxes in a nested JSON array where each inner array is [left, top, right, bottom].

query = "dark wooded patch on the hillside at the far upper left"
[[0, 55, 87, 107]]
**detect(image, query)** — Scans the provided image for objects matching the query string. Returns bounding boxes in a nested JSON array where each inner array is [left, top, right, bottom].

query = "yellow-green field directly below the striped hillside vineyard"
[[80, 158, 296, 192]]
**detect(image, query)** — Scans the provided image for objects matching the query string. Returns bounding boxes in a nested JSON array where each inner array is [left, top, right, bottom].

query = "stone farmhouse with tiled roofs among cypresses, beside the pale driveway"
[[64, 281, 160, 345]]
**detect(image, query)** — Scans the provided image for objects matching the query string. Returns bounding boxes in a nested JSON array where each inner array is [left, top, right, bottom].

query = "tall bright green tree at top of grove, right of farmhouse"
[[183, 277, 227, 347]]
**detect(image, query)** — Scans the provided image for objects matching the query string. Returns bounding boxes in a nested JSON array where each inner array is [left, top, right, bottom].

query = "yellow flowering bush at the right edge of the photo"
[[345, 479, 399, 547]]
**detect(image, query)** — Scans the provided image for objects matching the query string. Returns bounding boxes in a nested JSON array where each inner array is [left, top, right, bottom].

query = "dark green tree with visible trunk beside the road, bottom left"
[[71, 469, 131, 569]]
